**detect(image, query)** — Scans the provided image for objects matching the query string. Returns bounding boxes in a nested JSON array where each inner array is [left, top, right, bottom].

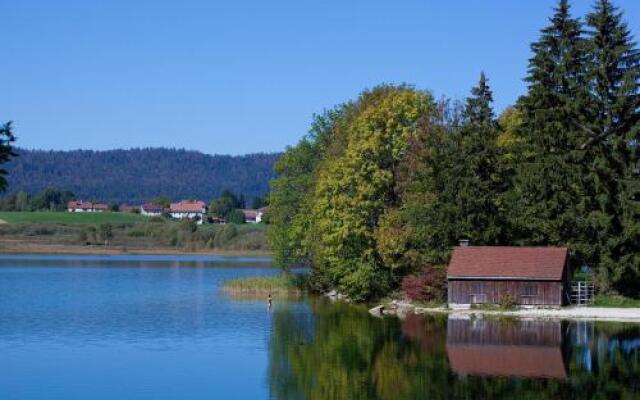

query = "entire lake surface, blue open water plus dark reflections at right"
[[0, 255, 640, 400]]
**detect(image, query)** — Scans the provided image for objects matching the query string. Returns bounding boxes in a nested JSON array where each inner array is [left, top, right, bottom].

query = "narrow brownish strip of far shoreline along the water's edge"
[[0, 239, 271, 258]]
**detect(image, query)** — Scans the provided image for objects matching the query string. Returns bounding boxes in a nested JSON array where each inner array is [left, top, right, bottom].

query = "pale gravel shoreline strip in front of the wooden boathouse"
[[369, 302, 640, 323]]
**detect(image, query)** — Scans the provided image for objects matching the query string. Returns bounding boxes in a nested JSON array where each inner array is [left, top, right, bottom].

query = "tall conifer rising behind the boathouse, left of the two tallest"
[[506, 0, 592, 255]]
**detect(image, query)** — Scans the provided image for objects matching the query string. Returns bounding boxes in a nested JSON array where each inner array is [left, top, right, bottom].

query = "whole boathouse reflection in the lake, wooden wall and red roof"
[[447, 316, 567, 379]]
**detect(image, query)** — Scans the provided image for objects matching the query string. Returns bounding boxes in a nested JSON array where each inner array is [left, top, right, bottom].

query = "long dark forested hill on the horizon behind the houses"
[[6, 148, 279, 204]]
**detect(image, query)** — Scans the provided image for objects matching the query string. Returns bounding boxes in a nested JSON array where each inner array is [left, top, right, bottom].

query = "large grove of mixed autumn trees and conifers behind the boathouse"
[[268, 0, 640, 300]]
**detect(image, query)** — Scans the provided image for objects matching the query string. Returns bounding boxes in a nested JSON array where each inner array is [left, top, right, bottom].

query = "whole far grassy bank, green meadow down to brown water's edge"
[[0, 212, 269, 255]]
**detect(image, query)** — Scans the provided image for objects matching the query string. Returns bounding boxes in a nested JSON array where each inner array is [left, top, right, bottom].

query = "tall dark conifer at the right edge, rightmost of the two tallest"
[[582, 0, 640, 295]]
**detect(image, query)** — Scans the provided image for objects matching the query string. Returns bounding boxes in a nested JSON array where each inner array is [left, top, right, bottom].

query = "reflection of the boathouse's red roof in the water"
[[447, 344, 567, 379]]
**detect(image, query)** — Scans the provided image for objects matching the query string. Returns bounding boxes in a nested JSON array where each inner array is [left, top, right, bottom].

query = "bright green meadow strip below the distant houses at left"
[[0, 211, 148, 224]]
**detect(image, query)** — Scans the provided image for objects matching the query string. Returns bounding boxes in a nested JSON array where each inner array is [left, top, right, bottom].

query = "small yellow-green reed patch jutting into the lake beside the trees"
[[224, 273, 307, 296]]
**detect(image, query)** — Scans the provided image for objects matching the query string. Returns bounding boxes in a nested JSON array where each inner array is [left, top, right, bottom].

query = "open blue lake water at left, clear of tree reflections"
[[0, 255, 305, 400]]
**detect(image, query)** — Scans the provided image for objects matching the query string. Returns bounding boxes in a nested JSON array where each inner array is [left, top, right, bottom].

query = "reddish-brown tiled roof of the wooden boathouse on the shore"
[[447, 246, 569, 280]]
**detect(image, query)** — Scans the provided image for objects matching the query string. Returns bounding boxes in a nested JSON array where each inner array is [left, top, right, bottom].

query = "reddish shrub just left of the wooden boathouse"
[[402, 265, 447, 302]]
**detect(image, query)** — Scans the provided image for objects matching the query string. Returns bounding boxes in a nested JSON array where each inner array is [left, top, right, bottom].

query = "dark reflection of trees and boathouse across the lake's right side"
[[269, 301, 640, 400]]
